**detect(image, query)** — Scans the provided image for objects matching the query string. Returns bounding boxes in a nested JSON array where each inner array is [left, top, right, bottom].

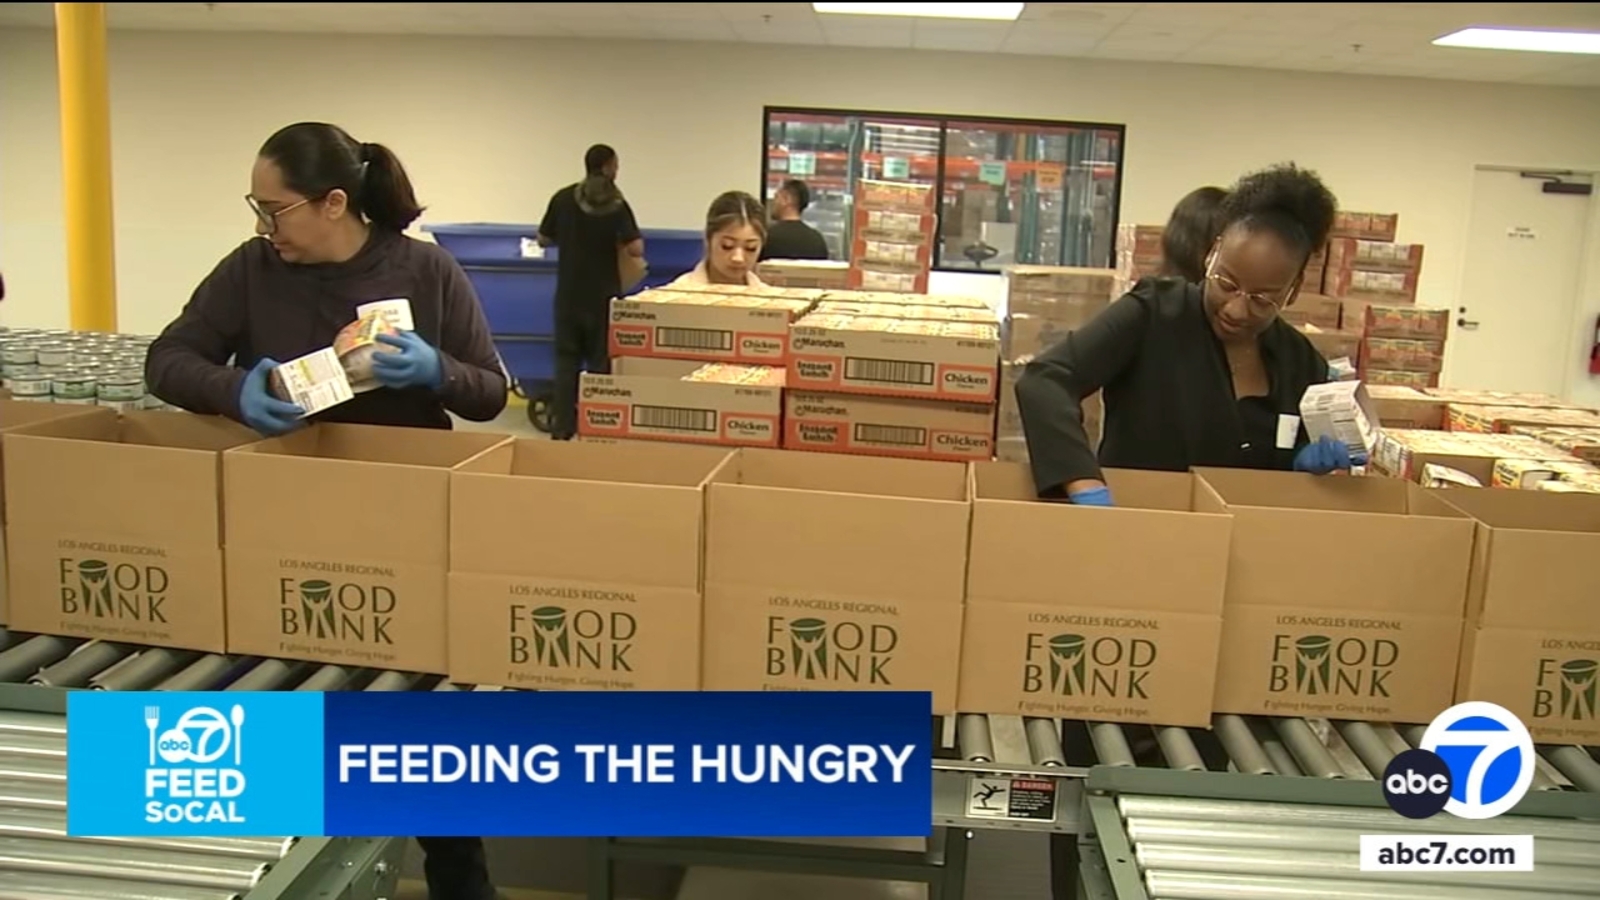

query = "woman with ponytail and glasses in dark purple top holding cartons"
[[146, 122, 506, 900]]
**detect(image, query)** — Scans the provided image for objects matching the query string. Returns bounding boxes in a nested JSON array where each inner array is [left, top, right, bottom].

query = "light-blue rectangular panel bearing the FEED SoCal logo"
[[67, 692, 323, 838]]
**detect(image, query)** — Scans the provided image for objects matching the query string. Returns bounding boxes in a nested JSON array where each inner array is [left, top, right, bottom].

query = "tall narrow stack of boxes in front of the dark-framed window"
[[848, 181, 939, 293]]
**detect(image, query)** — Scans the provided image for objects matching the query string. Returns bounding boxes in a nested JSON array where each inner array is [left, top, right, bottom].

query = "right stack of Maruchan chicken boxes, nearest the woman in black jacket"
[[782, 291, 1000, 461]]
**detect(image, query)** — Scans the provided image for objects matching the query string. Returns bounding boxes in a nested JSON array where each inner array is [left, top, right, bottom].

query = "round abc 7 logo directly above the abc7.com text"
[[1382, 701, 1536, 818]]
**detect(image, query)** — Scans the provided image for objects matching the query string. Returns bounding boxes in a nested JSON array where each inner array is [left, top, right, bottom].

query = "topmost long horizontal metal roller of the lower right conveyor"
[[1117, 794, 1600, 839]]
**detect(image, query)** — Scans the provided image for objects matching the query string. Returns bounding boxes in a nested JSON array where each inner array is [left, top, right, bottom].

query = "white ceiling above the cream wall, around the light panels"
[[0, 3, 1600, 86]]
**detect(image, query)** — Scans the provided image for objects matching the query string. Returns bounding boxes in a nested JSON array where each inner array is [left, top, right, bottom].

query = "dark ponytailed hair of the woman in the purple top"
[[261, 122, 422, 232]]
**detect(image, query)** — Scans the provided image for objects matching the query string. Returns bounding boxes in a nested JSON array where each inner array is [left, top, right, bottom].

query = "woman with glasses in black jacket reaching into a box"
[[1016, 165, 1362, 506]]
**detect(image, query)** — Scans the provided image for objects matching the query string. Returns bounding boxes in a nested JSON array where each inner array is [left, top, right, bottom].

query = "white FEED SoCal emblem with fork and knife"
[[144, 703, 245, 825]]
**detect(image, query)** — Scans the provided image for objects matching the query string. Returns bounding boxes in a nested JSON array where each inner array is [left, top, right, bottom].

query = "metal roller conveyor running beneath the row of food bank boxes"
[[0, 634, 1600, 900]]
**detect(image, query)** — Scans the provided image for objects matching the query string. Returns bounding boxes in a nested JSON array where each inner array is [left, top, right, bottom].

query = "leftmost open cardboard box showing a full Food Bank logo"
[[5, 410, 261, 653]]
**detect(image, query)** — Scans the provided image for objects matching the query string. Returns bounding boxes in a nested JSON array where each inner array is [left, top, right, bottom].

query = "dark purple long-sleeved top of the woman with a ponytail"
[[146, 229, 506, 428]]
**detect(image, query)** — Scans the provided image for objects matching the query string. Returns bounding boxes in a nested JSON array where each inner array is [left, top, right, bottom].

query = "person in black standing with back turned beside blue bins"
[[539, 144, 645, 440]]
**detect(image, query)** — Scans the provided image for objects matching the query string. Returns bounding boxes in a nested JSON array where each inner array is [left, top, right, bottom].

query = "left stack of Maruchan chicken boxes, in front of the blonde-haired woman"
[[578, 285, 822, 447]]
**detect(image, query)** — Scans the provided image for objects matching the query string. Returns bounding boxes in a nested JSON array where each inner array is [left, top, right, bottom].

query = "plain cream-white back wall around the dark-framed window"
[[0, 30, 1600, 342]]
